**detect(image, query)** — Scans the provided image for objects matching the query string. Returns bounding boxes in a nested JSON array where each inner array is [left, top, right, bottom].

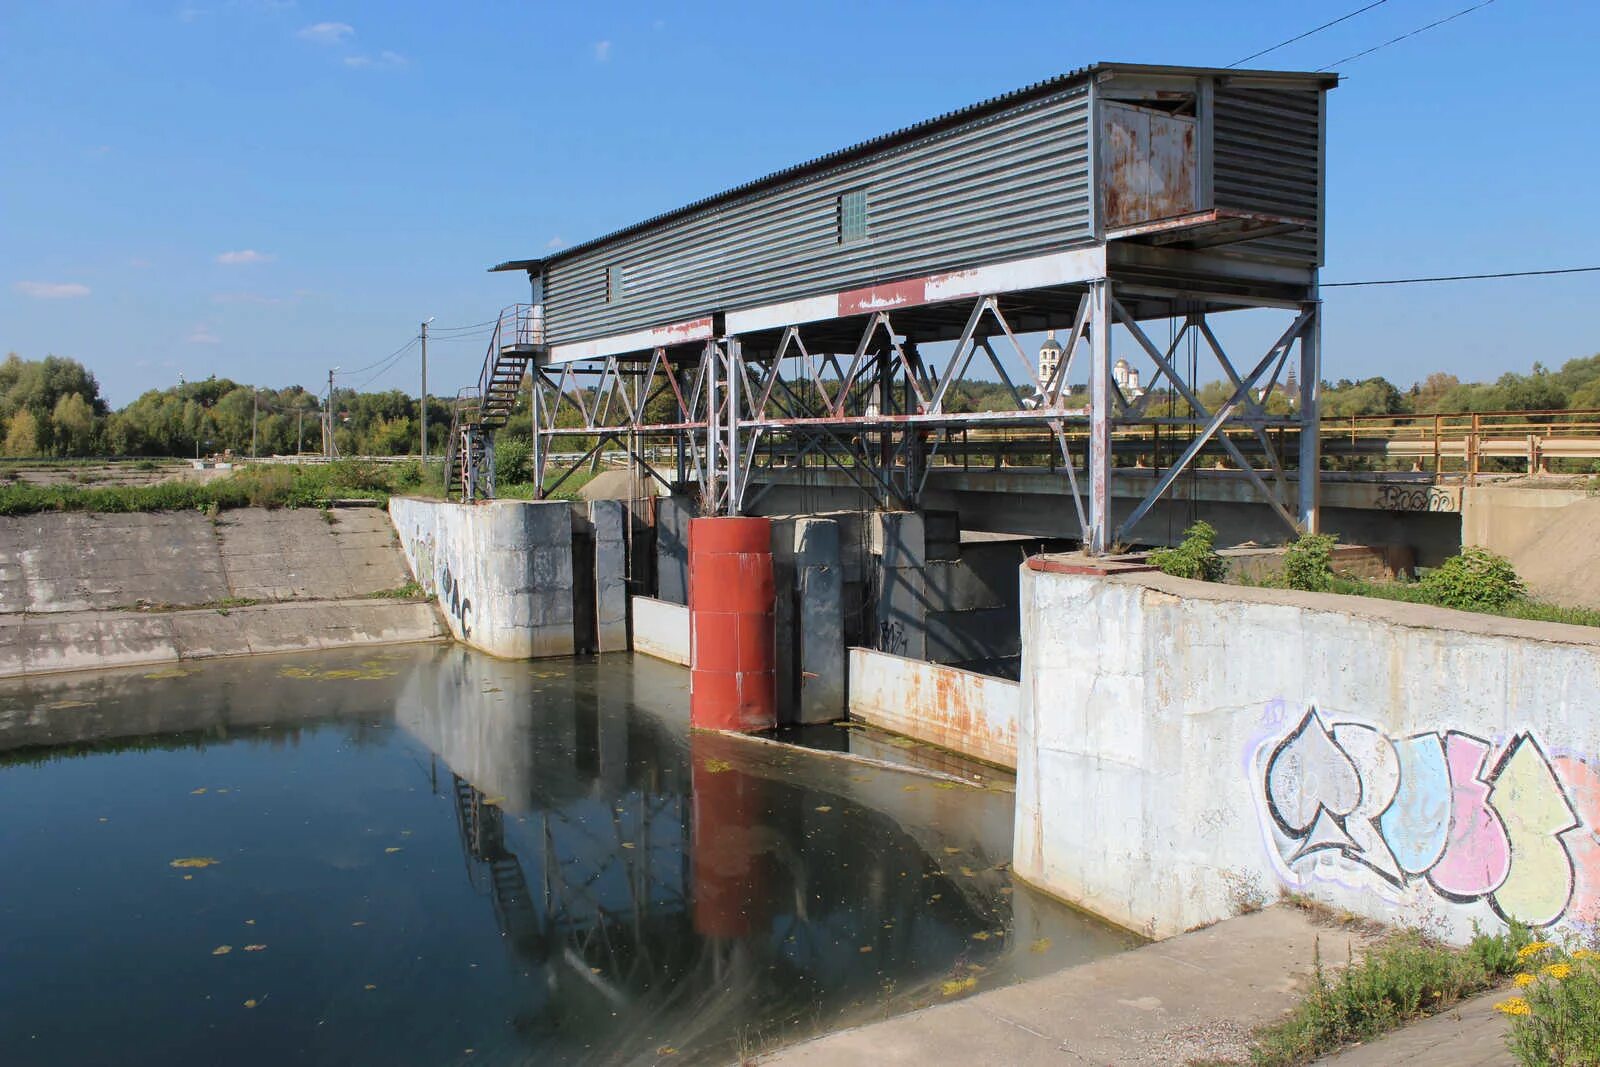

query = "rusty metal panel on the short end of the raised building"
[[1099, 101, 1200, 229]]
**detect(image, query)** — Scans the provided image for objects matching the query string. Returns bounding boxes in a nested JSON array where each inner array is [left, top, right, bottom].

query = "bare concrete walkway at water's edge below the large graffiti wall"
[[760, 907, 1363, 1067]]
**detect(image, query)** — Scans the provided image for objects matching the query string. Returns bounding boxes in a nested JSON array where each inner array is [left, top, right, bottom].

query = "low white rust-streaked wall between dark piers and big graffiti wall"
[[850, 648, 1018, 768]]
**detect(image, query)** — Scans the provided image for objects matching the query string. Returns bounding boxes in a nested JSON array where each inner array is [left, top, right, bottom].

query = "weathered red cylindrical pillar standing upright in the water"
[[690, 517, 778, 733]]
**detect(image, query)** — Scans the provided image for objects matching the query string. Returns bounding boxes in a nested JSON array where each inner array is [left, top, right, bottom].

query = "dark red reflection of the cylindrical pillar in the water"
[[690, 734, 765, 937]]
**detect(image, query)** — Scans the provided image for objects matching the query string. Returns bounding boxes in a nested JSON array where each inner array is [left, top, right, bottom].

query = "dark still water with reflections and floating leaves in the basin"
[[0, 645, 1131, 1065]]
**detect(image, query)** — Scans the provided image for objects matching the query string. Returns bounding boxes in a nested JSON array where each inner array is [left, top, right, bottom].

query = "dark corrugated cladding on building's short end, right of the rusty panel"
[[1211, 85, 1322, 264]]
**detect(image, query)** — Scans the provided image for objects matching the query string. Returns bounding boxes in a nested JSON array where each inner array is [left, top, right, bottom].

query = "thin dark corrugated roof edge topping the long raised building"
[[490, 62, 1339, 272]]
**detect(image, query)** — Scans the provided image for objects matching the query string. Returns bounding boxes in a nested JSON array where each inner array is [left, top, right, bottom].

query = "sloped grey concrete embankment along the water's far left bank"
[[0, 509, 445, 677]]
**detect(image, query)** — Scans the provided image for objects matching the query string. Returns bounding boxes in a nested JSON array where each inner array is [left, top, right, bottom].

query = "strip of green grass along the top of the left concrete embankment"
[[0, 461, 421, 515]]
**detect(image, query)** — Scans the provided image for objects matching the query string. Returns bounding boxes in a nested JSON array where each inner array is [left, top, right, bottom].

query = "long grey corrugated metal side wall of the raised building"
[[546, 85, 1094, 344]]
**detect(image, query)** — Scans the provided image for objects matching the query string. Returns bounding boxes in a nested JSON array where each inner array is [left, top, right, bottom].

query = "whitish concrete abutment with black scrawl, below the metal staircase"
[[389, 496, 573, 659]]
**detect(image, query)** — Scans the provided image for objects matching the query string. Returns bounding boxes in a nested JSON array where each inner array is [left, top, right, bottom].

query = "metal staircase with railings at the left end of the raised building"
[[445, 304, 544, 504]]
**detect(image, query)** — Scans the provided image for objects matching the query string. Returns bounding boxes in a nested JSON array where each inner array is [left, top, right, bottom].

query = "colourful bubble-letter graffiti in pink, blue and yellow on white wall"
[[1256, 709, 1600, 926]]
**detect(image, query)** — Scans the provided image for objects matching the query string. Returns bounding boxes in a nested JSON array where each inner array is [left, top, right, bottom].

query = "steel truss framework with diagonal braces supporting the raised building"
[[508, 280, 1320, 552]]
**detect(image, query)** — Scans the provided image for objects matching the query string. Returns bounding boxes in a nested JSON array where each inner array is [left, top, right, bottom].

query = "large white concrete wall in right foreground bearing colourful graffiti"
[[1014, 557, 1600, 941]]
